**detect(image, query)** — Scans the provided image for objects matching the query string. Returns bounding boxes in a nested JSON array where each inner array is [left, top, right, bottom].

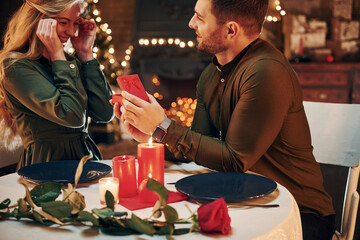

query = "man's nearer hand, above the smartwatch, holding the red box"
[[120, 91, 166, 135]]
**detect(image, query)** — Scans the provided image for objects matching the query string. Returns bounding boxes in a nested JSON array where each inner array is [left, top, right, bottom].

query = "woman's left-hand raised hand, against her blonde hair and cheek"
[[36, 18, 66, 61]]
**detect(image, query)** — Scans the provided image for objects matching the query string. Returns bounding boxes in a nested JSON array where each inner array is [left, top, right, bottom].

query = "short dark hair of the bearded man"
[[212, 0, 269, 36]]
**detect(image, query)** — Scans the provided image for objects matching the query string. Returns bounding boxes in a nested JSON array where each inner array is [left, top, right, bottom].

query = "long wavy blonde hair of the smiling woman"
[[0, 0, 84, 148]]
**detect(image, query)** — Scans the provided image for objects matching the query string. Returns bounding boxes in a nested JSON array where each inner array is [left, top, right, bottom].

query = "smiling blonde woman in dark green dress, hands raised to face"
[[0, 0, 113, 169]]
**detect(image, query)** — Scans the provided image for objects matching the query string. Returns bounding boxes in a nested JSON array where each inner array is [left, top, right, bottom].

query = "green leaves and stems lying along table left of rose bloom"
[[0, 156, 196, 239]]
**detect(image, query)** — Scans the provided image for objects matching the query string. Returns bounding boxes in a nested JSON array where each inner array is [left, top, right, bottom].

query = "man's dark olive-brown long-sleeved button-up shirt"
[[163, 39, 334, 216]]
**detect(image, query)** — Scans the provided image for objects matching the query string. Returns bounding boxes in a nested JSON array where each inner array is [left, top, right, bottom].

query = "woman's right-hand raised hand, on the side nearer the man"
[[71, 19, 96, 61]]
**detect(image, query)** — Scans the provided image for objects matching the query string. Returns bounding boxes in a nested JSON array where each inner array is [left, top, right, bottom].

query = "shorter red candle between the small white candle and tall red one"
[[112, 155, 137, 198]]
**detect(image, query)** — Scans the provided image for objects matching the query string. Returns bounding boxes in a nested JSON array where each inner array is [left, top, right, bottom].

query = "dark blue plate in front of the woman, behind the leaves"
[[18, 160, 111, 183]]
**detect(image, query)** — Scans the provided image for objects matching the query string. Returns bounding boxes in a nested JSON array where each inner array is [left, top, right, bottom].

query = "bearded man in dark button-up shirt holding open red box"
[[114, 0, 334, 239]]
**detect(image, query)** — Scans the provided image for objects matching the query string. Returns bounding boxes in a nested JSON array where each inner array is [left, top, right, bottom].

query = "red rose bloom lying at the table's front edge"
[[197, 198, 231, 234]]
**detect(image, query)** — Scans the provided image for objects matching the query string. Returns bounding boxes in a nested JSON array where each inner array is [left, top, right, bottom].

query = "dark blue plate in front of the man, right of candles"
[[175, 172, 277, 203]]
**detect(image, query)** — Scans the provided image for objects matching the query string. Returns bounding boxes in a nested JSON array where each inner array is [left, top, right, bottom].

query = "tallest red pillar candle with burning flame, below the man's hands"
[[137, 138, 165, 185]]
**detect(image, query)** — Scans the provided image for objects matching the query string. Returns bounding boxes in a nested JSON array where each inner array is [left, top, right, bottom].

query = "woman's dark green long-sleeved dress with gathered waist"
[[3, 56, 113, 169]]
